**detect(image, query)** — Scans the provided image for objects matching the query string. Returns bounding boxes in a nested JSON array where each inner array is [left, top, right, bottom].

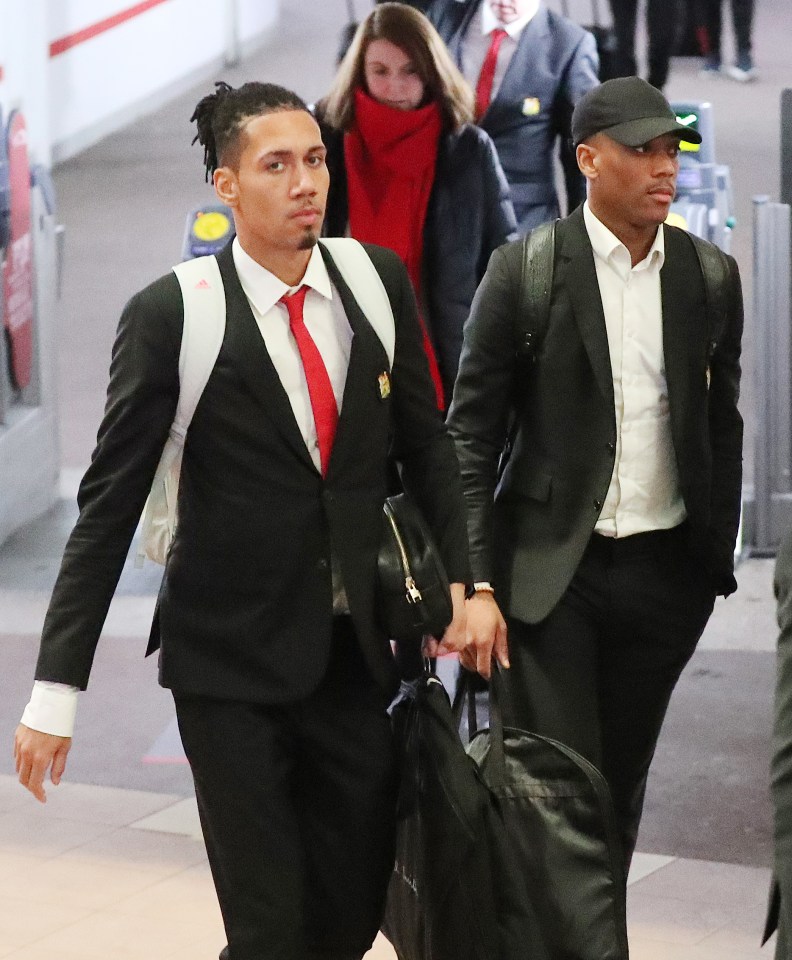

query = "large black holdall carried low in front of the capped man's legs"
[[467, 665, 629, 960]]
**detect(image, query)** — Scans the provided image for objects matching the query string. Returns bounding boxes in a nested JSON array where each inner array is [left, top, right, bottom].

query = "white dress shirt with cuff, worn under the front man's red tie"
[[21, 239, 352, 737]]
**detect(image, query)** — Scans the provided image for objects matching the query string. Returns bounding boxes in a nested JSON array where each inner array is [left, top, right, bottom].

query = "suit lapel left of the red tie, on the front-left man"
[[217, 243, 316, 470]]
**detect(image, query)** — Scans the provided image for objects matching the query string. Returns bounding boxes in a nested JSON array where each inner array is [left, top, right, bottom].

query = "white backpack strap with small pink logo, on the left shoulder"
[[171, 256, 226, 445]]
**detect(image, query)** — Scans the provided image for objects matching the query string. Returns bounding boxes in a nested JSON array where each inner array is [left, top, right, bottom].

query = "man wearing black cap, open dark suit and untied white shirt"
[[448, 77, 743, 866]]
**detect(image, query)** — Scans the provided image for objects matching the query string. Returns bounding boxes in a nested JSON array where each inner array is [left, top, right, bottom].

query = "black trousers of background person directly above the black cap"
[[610, 0, 679, 90]]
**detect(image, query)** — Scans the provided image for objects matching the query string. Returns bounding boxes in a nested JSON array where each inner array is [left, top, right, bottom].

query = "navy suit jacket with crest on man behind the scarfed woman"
[[428, 0, 599, 233]]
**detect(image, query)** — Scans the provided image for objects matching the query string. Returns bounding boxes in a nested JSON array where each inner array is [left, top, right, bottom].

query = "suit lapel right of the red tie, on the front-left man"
[[321, 247, 389, 472]]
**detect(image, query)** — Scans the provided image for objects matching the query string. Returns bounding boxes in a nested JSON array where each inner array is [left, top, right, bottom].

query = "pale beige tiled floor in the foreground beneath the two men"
[[0, 776, 772, 960]]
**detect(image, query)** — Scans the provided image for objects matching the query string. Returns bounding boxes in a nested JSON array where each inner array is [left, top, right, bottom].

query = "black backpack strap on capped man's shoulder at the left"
[[514, 220, 558, 360]]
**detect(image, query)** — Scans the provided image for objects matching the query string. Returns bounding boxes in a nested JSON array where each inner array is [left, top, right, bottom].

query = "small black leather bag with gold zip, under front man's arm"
[[377, 493, 452, 643]]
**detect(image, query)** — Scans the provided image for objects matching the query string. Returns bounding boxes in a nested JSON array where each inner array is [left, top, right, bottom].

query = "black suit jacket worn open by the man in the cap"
[[449, 208, 743, 623]]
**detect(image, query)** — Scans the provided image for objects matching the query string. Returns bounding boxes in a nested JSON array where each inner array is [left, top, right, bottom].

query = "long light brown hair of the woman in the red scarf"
[[323, 3, 475, 130]]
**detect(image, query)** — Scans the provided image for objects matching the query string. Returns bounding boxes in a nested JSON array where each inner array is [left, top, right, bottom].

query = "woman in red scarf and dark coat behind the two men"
[[316, 3, 517, 410]]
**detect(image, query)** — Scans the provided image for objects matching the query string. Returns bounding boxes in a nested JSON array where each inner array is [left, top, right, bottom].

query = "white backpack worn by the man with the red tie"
[[135, 237, 396, 566]]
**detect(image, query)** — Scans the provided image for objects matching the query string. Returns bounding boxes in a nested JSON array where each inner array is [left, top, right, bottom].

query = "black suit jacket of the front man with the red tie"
[[36, 245, 468, 703]]
